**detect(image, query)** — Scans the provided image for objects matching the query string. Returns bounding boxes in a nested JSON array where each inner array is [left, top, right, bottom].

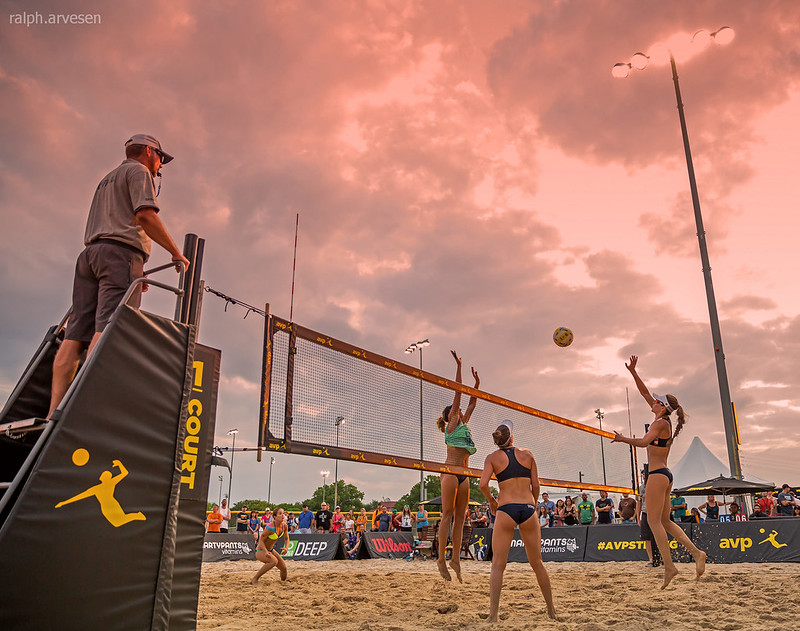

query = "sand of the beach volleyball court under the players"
[[197, 559, 800, 631]]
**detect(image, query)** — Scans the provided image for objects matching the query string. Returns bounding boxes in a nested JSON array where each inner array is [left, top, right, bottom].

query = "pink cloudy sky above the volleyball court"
[[0, 0, 800, 501]]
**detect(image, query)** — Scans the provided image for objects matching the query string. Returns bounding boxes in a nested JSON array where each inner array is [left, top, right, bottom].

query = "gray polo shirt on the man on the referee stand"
[[83, 160, 159, 260]]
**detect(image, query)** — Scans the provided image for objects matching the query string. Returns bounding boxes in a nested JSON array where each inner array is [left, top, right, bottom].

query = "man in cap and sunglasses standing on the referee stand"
[[48, 134, 189, 417]]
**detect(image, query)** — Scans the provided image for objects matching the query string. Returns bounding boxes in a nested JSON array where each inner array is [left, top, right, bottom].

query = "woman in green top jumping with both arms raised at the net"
[[436, 351, 481, 582]]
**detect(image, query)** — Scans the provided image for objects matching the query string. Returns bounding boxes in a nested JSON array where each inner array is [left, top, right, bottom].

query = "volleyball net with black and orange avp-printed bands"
[[258, 314, 636, 492]]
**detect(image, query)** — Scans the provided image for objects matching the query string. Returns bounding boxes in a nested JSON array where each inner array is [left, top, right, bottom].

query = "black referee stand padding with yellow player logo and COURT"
[[0, 305, 220, 631]]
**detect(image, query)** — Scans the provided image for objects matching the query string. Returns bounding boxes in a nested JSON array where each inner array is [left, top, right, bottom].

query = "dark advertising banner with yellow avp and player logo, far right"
[[692, 517, 800, 563]]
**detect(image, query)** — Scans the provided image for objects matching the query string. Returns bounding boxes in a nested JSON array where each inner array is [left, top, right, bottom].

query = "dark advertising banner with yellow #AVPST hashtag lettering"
[[584, 524, 693, 563]]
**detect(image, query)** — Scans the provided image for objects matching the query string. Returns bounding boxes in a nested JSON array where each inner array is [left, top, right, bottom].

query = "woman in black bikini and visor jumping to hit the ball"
[[612, 355, 706, 589]]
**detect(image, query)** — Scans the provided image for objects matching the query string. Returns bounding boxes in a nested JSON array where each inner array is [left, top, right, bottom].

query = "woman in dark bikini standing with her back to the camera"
[[481, 421, 556, 622]]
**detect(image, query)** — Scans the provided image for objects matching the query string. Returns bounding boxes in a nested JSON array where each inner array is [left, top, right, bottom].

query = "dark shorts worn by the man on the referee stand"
[[66, 241, 144, 343]]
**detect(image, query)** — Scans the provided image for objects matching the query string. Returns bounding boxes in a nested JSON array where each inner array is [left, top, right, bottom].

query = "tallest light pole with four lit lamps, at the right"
[[611, 26, 742, 479]]
